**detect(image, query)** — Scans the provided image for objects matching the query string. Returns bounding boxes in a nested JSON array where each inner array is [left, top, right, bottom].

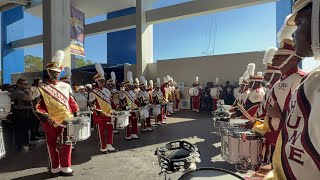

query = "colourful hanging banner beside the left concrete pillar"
[[70, 7, 85, 56]]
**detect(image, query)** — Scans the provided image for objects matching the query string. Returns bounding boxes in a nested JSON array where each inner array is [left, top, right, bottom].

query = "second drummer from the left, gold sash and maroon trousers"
[[89, 63, 116, 153]]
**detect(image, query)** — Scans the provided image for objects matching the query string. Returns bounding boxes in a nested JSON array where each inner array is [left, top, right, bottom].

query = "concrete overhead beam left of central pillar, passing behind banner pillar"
[[11, 14, 136, 49]]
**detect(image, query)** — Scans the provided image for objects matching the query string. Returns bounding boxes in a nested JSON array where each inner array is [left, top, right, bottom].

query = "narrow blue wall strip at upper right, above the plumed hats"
[[276, 0, 292, 46]]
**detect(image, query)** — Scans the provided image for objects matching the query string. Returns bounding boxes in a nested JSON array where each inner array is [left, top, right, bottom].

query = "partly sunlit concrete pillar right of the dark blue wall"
[[136, 0, 153, 77]]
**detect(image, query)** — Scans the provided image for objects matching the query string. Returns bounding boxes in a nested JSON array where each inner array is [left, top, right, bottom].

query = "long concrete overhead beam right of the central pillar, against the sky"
[[146, 0, 278, 24]]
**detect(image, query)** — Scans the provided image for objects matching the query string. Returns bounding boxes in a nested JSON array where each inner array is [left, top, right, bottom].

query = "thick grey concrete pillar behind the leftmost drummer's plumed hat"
[[42, 0, 71, 71]]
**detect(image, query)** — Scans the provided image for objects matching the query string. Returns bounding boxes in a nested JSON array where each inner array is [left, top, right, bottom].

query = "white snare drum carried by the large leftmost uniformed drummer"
[[67, 116, 91, 143]]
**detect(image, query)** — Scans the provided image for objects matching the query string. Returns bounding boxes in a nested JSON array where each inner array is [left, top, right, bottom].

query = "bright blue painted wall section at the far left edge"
[[1, 6, 24, 84]]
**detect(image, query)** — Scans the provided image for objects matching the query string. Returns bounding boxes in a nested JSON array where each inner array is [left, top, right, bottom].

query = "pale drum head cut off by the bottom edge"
[[179, 168, 244, 180]]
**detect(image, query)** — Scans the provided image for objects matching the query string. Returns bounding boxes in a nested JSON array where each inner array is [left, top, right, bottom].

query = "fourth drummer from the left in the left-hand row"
[[137, 76, 153, 132]]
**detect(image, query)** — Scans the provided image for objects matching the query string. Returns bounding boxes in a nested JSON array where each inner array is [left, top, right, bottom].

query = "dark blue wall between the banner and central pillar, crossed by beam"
[[107, 7, 136, 64]]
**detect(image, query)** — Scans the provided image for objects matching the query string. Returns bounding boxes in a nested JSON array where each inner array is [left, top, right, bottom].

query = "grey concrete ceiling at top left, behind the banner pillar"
[[25, 0, 136, 18]]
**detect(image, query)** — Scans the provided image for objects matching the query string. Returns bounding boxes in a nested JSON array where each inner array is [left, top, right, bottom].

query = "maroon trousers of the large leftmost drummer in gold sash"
[[42, 123, 72, 169]]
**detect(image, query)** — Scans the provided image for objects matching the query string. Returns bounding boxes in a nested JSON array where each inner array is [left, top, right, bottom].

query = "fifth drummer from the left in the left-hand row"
[[152, 78, 166, 125]]
